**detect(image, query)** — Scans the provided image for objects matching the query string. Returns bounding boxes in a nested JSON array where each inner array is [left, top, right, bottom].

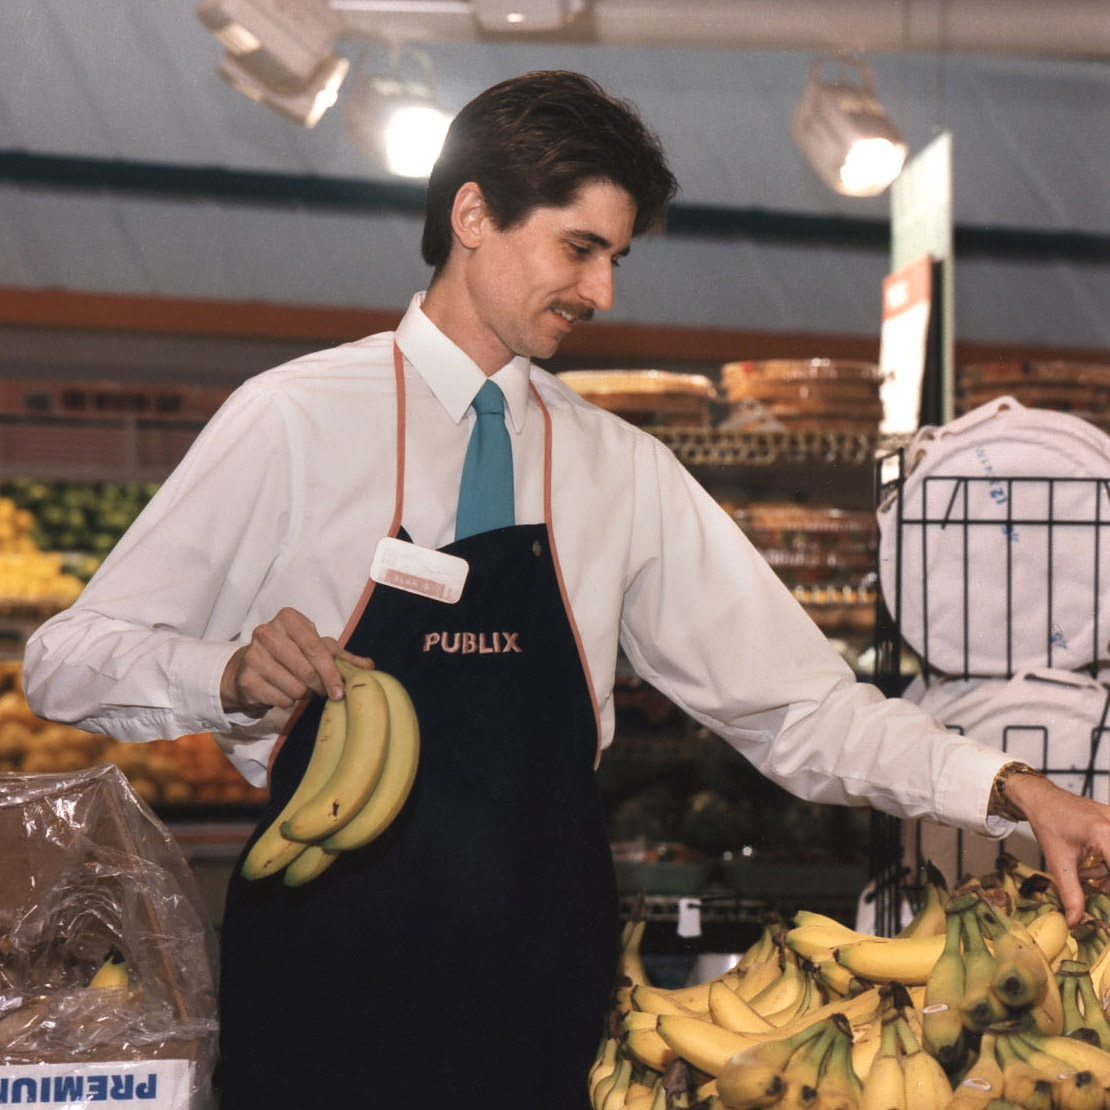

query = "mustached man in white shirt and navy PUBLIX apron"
[[24, 72, 1110, 1110]]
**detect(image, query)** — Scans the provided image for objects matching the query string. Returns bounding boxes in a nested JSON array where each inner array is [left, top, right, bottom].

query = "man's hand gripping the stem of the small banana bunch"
[[220, 608, 373, 717]]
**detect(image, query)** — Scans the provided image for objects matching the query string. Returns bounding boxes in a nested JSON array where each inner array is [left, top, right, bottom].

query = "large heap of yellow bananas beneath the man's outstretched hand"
[[589, 855, 1110, 1110]]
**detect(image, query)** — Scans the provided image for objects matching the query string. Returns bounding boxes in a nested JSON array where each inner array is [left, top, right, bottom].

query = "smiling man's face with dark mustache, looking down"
[[466, 181, 636, 364]]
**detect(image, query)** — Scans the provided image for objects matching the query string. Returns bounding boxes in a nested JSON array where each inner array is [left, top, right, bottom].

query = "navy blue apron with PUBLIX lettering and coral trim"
[[221, 354, 617, 1110]]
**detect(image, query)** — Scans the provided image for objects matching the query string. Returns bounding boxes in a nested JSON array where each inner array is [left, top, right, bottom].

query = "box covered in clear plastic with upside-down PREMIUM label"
[[0, 764, 218, 1110]]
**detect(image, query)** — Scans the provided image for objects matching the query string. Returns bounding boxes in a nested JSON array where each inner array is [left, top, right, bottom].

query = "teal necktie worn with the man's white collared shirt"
[[455, 380, 515, 539]]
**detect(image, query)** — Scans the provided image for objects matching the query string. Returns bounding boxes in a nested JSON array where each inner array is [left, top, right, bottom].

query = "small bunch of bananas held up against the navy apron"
[[242, 658, 420, 887]]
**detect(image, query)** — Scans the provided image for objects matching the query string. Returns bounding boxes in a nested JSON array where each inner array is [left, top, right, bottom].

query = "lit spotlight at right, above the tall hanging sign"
[[790, 58, 907, 196]]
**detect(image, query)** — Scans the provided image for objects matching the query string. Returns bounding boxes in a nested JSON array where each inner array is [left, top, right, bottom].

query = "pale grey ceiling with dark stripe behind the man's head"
[[0, 0, 1110, 372]]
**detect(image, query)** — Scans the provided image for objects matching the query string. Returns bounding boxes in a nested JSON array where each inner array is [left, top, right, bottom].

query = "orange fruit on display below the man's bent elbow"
[[0, 662, 266, 807]]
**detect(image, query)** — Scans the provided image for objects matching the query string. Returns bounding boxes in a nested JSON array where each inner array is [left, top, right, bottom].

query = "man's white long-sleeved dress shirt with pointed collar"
[[24, 294, 1011, 835]]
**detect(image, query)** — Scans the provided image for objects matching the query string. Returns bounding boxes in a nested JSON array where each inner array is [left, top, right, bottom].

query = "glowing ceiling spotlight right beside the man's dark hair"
[[343, 47, 452, 178]]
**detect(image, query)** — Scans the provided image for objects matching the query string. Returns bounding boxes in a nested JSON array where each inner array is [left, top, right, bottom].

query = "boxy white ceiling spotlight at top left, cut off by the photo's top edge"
[[196, 0, 350, 128]]
